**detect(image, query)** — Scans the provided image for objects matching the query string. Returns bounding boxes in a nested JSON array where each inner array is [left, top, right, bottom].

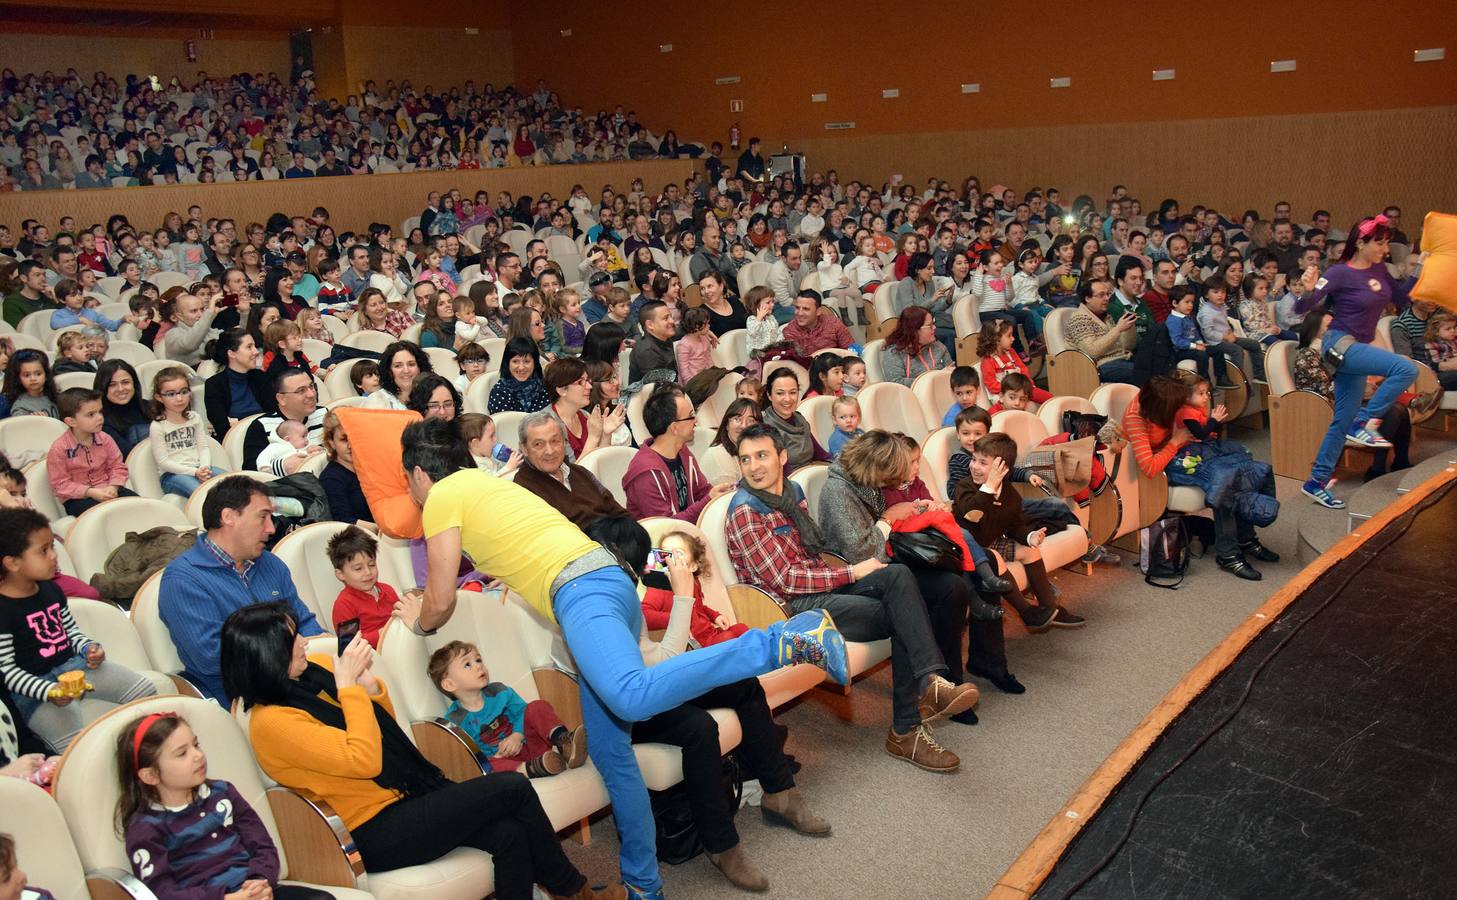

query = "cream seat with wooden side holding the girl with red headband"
[[52, 696, 399, 900]]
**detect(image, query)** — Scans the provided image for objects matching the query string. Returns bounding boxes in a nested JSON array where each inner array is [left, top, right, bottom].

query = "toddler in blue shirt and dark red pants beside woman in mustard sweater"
[[428, 641, 587, 778]]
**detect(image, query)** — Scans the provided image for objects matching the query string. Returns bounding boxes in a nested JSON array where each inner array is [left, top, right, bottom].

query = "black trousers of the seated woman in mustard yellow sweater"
[[353, 772, 587, 900]]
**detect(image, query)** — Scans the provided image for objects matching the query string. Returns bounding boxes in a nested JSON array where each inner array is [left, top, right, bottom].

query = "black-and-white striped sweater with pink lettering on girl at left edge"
[[0, 581, 92, 700]]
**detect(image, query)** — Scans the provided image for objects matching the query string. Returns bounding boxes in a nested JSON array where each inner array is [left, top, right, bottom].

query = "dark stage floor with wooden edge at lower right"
[[1036, 471, 1457, 900]]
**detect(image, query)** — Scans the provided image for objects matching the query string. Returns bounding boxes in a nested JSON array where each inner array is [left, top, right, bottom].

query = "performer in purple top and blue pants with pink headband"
[[1295, 209, 1421, 510]]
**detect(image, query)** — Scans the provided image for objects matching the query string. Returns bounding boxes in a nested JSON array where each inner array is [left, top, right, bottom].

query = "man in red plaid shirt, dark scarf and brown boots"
[[726, 425, 976, 772]]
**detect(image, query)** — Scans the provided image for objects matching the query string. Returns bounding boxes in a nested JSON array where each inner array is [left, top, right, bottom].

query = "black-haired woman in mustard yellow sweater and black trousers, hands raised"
[[221, 603, 625, 900]]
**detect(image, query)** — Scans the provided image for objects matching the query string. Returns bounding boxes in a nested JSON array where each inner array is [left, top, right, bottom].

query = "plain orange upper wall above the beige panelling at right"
[[511, 0, 1457, 141]]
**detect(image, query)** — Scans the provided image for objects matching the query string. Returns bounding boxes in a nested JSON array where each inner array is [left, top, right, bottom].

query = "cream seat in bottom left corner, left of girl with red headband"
[[0, 778, 132, 900]]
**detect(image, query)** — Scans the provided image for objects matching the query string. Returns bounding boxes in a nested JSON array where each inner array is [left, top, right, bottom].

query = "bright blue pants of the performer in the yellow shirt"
[[554, 568, 775, 891]]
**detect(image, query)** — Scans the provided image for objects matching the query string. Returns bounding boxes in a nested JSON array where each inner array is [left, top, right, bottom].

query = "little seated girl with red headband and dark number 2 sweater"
[[117, 712, 329, 900]]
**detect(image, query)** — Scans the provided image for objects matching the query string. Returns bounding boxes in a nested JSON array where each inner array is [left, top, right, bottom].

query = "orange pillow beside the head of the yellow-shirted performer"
[[334, 406, 424, 539]]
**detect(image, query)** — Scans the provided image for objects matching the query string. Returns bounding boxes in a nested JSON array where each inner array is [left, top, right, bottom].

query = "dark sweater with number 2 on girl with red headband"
[[127, 781, 278, 900]]
